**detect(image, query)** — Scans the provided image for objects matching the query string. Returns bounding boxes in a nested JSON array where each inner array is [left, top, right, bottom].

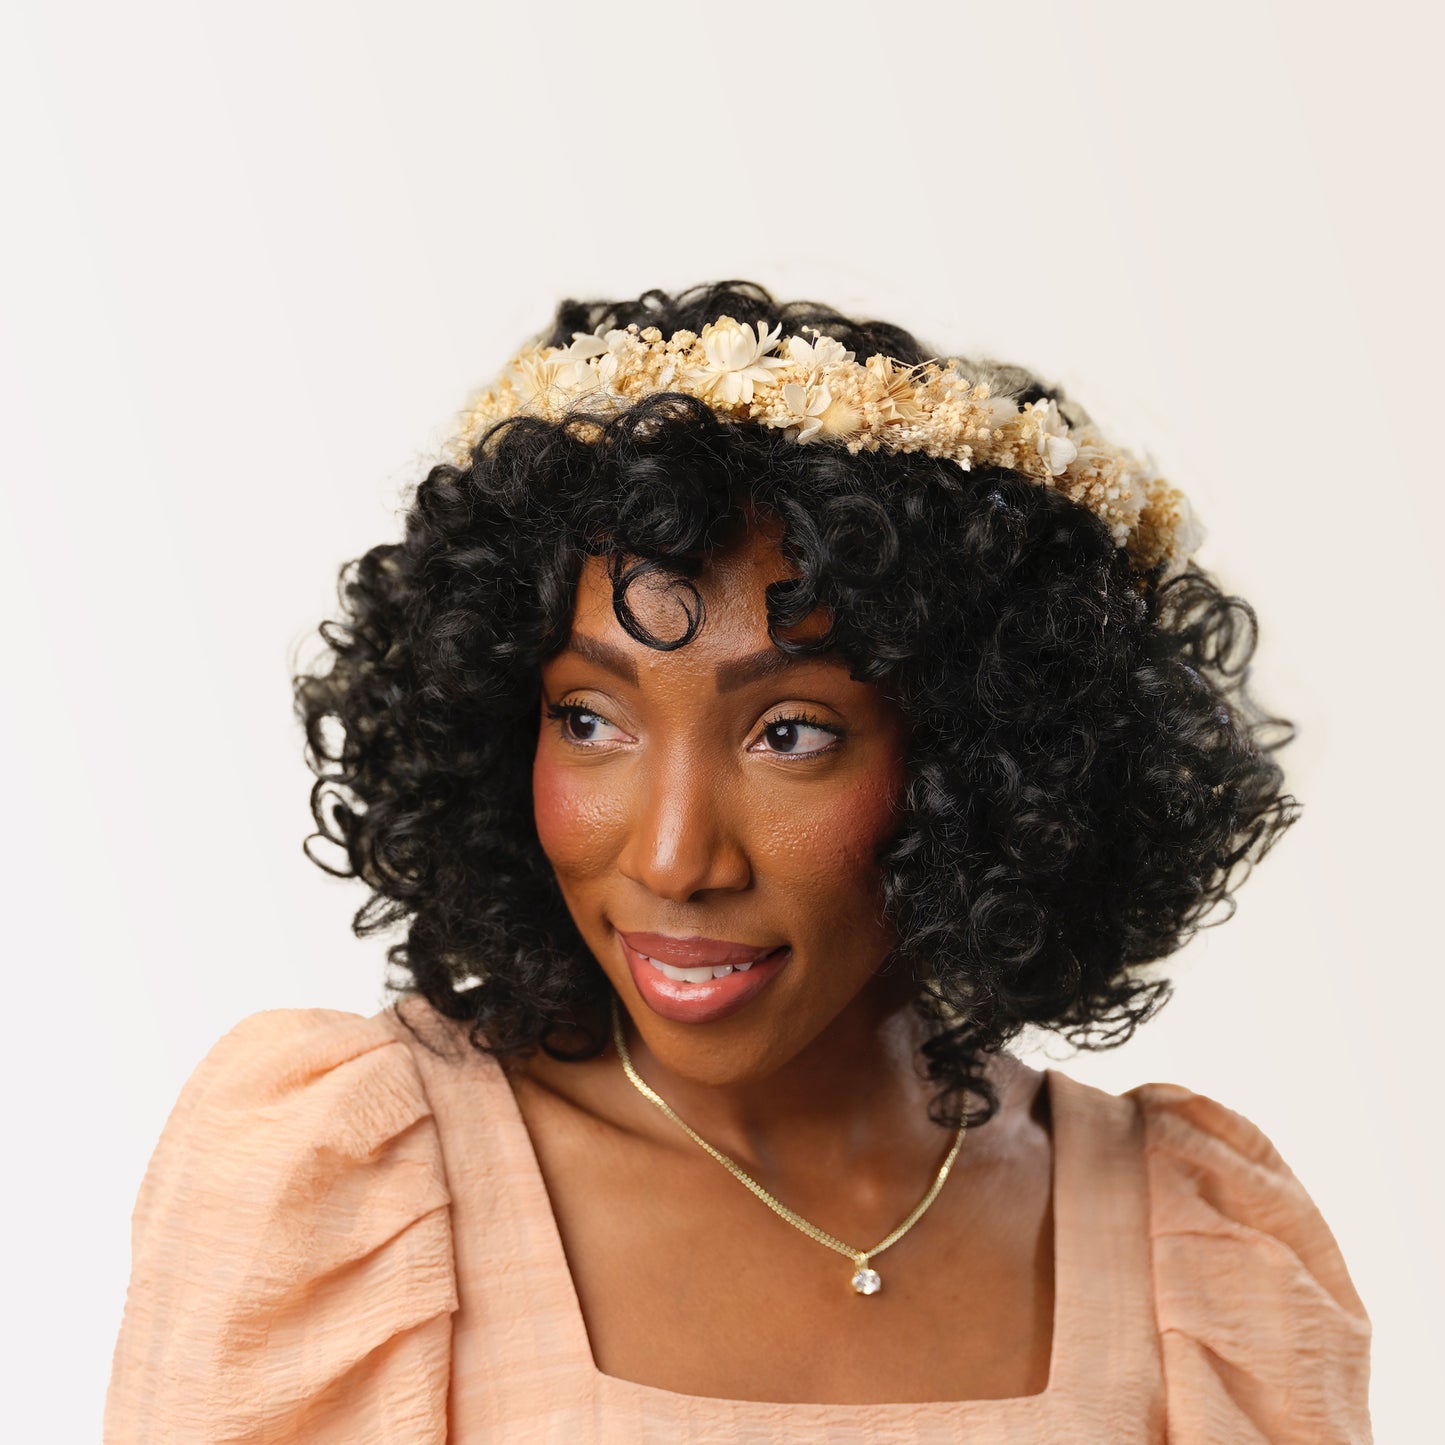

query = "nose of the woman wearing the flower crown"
[[617, 760, 753, 903]]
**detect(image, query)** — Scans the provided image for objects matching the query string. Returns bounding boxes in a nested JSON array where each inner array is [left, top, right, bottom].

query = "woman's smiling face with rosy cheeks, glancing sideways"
[[532, 525, 906, 1084]]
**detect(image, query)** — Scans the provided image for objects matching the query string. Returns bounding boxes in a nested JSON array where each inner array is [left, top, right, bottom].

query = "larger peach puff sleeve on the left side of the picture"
[[104, 1009, 457, 1445]]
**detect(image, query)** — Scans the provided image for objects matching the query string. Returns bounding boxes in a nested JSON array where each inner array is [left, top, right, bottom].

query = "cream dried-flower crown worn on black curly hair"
[[449, 316, 1204, 577]]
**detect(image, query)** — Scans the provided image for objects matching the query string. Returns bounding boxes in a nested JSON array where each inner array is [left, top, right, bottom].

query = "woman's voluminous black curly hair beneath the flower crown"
[[295, 282, 1298, 1124]]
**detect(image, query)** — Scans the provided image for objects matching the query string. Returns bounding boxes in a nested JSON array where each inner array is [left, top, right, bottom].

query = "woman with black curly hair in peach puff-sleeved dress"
[[107, 283, 1368, 1445]]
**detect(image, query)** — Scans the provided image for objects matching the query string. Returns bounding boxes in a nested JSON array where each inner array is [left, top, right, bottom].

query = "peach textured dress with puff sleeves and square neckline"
[[105, 998, 1370, 1445]]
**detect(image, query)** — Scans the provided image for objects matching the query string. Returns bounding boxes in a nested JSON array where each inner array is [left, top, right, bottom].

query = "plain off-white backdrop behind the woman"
[[0, 0, 1445, 1442]]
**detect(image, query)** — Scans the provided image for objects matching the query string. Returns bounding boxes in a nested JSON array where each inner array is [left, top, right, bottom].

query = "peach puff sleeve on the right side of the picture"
[[1131, 1084, 1371, 1445]]
